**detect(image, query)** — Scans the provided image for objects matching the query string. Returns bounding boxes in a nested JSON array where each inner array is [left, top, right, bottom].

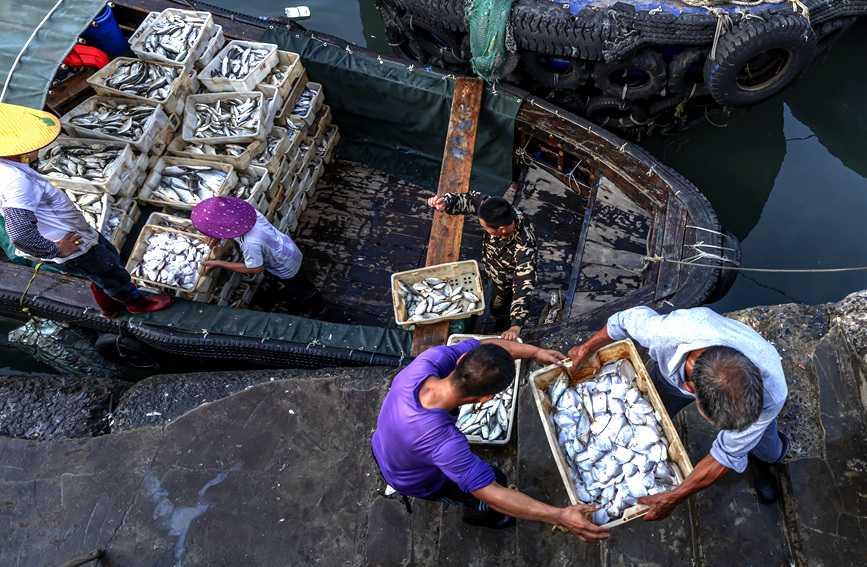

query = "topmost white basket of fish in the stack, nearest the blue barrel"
[[129, 8, 221, 71]]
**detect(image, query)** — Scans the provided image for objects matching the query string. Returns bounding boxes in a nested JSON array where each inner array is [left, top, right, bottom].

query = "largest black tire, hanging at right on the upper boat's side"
[[704, 14, 816, 106]]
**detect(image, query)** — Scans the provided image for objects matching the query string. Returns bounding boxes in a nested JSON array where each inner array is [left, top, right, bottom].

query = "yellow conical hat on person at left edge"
[[0, 102, 60, 156]]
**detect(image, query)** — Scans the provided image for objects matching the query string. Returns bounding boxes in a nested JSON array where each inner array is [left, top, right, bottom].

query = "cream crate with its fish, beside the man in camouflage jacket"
[[391, 260, 485, 327]]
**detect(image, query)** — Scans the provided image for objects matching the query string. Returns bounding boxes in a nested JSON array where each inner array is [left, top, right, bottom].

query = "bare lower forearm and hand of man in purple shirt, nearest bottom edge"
[[472, 482, 609, 542]]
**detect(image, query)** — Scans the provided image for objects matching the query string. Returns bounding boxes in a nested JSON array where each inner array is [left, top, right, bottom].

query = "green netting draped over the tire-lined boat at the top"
[[465, 0, 515, 83]]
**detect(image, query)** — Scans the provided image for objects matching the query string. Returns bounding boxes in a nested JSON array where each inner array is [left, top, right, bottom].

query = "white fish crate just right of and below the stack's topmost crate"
[[199, 39, 278, 93]]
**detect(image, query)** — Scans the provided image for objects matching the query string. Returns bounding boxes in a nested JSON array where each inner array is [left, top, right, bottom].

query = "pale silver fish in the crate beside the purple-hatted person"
[[130, 232, 209, 290]]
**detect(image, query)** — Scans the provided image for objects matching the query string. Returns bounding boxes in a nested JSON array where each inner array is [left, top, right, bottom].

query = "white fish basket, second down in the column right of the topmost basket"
[[181, 91, 268, 144]]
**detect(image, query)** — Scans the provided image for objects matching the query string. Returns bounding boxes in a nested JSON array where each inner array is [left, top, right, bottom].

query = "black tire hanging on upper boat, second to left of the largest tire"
[[593, 49, 666, 100]]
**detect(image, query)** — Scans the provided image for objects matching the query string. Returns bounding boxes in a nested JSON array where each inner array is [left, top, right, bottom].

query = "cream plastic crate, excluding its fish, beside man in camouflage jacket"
[[391, 260, 485, 327]]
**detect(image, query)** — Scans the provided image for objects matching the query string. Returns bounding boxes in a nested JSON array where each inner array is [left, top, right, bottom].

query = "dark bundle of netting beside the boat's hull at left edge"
[[9, 317, 123, 378]]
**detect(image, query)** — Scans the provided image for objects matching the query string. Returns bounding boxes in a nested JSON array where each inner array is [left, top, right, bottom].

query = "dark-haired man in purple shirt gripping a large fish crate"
[[371, 339, 608, 541]]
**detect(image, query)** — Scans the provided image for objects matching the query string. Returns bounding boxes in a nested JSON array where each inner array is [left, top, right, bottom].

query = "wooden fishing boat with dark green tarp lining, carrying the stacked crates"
[[0, 0, 739, 369]]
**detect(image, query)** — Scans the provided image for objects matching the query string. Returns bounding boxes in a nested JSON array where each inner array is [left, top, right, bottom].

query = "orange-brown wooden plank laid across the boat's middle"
[[412, 77, 484, 356]]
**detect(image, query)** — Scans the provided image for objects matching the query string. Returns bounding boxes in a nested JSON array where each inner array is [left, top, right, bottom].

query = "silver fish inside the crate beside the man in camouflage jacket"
[[395, 278, 479, 321]]
